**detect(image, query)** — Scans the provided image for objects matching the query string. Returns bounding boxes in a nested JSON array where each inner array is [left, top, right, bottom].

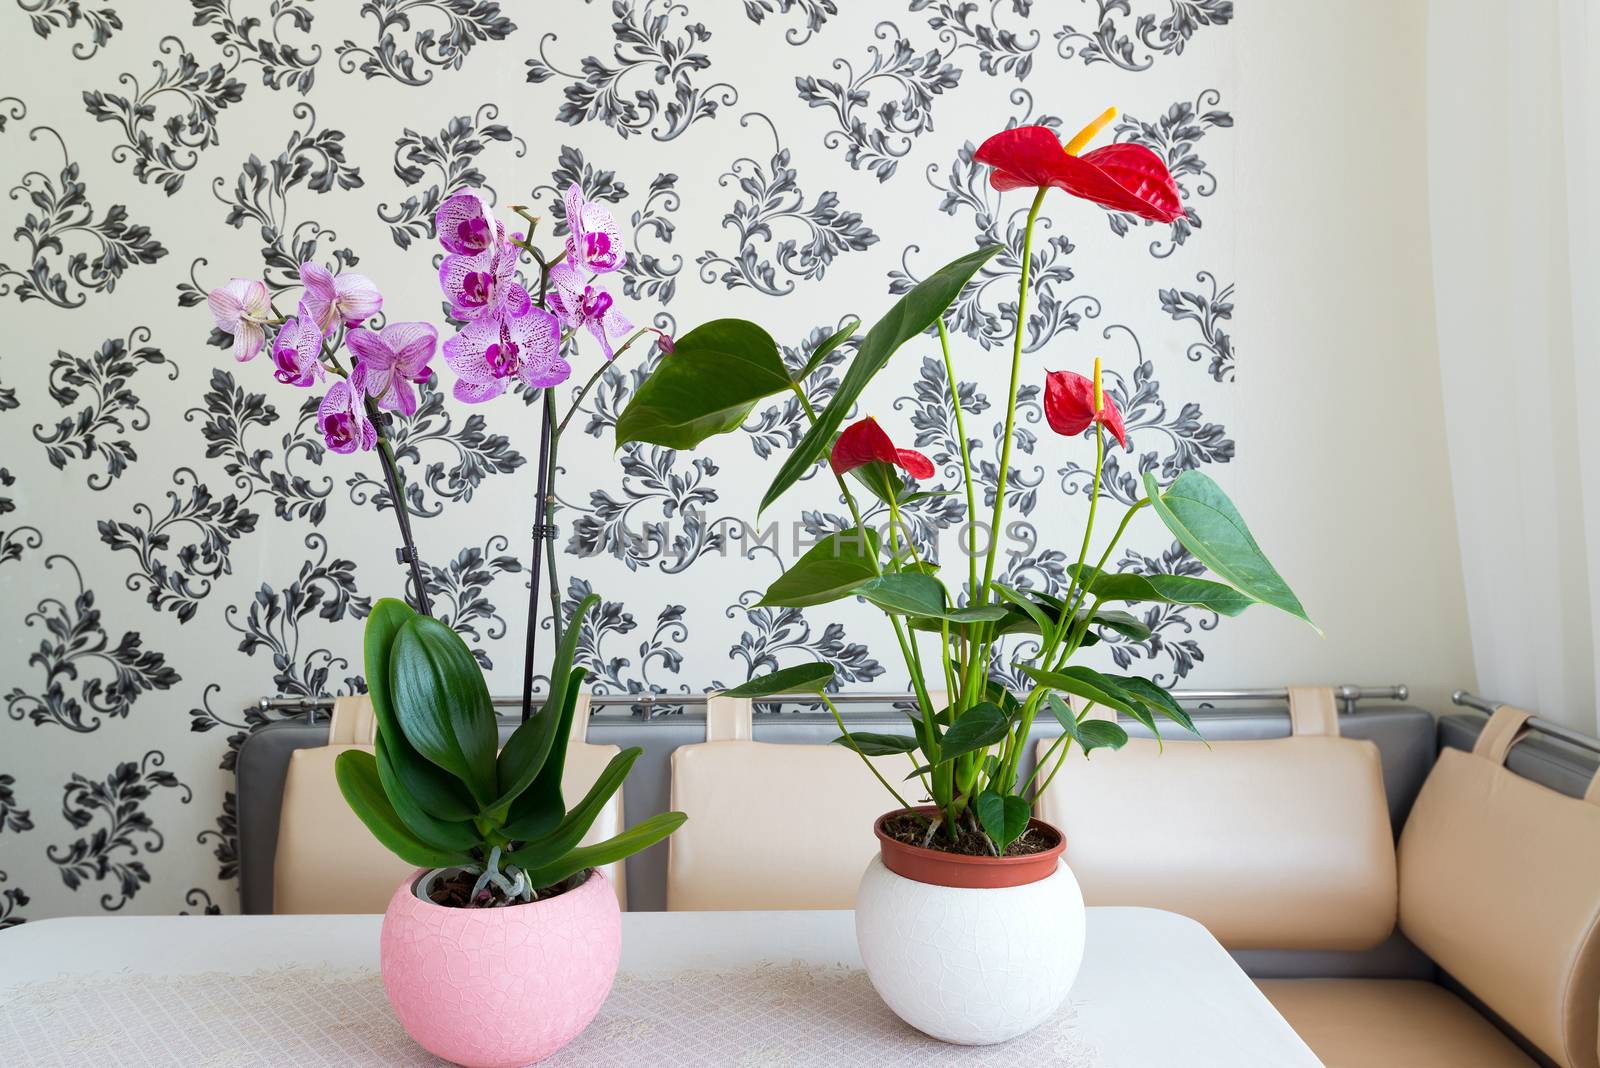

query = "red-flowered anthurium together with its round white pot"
[[616, 109, 1310, 1044]]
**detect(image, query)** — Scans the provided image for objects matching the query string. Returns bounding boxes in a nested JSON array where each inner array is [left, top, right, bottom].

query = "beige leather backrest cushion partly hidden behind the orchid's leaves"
[[272, 699, 627, 915]]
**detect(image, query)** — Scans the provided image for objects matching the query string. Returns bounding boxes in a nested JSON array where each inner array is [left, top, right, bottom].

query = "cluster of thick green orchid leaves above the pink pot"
[[334, 595, 685, 907]]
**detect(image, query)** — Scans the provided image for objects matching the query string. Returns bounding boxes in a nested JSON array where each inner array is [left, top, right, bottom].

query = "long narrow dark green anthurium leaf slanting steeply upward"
[[762, 245, 1000, 510]]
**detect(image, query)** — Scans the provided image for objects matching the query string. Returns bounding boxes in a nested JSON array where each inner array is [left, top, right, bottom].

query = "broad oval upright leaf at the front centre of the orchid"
[[389, 616, 499, 806]]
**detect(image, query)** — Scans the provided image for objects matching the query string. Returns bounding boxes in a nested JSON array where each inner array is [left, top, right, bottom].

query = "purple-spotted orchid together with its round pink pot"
[[208, 184, 685, 1065]]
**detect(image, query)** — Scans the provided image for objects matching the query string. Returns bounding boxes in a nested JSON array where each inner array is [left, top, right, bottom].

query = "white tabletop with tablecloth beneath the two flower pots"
[[0, 908, 1318, 1068]]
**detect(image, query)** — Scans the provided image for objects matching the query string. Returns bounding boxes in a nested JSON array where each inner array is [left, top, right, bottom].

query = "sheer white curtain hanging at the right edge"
[[1433, 0, 1600, 731]]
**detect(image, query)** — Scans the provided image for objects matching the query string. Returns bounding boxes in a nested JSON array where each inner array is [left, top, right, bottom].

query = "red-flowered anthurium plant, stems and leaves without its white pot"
[[616, 109, 1310, 855]]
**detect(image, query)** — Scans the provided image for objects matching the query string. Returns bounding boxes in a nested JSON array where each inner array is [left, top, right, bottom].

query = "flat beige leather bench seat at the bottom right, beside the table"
[[1258, 978, 1534, 1068]]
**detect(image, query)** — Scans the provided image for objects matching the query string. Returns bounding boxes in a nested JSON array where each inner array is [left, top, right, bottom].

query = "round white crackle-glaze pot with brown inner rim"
[[856, 812, 1083, 1046]]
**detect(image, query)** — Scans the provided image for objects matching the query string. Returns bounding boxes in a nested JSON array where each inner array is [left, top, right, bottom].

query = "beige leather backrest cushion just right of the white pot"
[[1038, 737, 1395, 950]]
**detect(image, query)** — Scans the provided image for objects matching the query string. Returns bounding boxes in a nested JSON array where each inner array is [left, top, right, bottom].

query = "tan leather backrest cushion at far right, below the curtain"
[[1400, 707, 1600, 1068]]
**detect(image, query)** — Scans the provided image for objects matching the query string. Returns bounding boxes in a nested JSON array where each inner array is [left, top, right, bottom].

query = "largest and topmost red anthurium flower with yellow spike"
[[973, 107, 1184, 222]]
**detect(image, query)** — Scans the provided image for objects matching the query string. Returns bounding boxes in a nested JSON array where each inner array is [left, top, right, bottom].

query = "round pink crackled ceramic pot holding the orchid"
[[381, 871, 622, 1068]]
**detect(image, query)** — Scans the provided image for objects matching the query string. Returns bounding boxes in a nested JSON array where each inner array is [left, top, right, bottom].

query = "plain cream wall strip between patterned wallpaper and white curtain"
[[1206, 0, 1475, 711]]
